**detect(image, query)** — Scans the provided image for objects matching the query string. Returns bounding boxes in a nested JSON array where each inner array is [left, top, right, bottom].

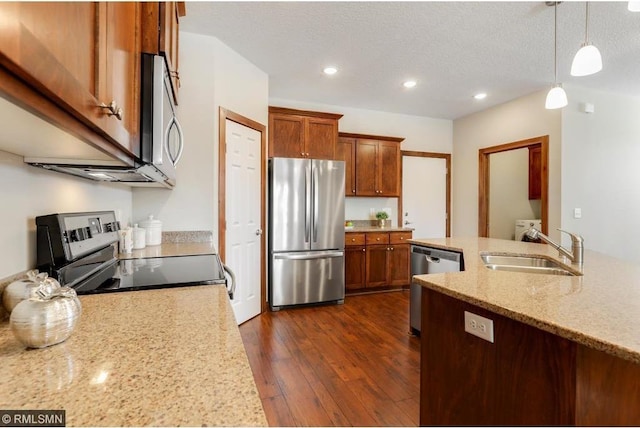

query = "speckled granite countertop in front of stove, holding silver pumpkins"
[[0, 284, 267, 426]]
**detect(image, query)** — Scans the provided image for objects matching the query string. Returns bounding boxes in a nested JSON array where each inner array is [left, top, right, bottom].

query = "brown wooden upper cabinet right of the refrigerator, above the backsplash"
[[337, 133, 404, 197]]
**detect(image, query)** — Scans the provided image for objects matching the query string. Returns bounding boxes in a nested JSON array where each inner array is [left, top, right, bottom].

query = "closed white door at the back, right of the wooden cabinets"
[[402, 156, 447, 239]]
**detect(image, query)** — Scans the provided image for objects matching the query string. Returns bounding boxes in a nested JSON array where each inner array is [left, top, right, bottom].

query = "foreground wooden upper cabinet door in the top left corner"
[[0, 2, 99, 128]]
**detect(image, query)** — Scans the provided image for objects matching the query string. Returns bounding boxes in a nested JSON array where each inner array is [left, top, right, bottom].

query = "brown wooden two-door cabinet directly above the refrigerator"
[[269, 107, 342, 159]]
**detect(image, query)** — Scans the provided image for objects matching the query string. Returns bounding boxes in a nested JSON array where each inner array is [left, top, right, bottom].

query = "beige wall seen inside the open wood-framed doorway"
[[489, 148, 540, 239]]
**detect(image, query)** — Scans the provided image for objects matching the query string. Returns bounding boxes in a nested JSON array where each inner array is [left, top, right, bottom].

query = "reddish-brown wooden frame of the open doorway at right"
[[478, 135, 549, 237]]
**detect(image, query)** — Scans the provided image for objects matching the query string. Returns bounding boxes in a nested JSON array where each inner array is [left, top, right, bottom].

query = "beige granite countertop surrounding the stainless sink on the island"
[[409, 238, 640, 363]]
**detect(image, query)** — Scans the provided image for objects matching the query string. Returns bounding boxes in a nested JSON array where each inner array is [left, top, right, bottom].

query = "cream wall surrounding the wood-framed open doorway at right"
[[452, 91, 561, 239]]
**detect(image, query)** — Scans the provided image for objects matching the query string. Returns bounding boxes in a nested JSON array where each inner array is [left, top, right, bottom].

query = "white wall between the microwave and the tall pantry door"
[[133, 32, 268, 242]]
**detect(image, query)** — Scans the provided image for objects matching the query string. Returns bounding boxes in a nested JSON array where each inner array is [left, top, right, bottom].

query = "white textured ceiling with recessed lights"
[[180, 2, 640, 119]]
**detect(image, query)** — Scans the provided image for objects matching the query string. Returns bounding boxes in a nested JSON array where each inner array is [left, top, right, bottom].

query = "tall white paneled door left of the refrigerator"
[[224, 119, 263, 324]]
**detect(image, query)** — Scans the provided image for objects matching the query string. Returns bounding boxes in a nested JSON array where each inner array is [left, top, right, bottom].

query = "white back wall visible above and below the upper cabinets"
[[269, 98, 453, 221]]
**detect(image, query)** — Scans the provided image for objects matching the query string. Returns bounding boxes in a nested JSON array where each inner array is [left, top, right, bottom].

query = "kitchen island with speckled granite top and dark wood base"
[[411, 238, 640, 425]]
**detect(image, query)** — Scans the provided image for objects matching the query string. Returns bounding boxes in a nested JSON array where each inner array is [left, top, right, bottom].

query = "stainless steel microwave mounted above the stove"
[[24, 54, 184, 188]]
